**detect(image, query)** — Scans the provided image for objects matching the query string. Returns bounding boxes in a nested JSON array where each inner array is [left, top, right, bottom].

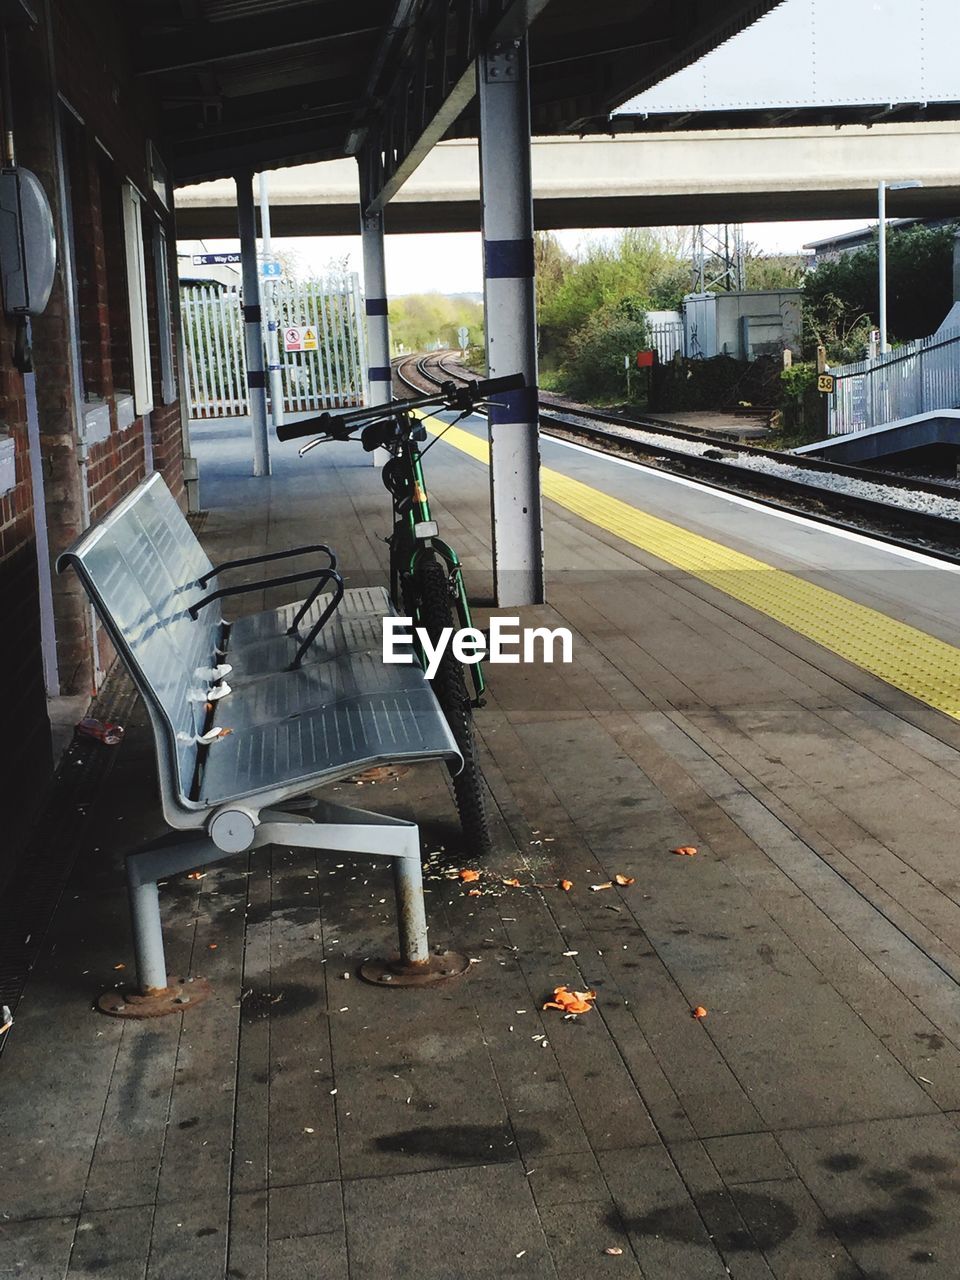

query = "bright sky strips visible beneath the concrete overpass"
[[180, 220, 865, 297]]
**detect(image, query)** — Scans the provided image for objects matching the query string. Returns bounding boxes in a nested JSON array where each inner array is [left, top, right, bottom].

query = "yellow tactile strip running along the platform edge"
[[426, 419, 960, 719]]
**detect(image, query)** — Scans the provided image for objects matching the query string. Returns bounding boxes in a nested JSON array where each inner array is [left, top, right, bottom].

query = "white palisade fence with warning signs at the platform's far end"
[[180, 274, 366, 419]]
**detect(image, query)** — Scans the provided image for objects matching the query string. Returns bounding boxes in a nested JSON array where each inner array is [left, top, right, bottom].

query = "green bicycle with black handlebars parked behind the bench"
[[276, 374, 525, 858]]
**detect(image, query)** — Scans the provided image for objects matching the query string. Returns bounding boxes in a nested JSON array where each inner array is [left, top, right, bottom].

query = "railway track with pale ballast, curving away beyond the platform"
[[394, 352, 960, 564]]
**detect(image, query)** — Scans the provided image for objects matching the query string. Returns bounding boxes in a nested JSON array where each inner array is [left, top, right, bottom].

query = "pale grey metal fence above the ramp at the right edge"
[[828, 329, 960, 435]]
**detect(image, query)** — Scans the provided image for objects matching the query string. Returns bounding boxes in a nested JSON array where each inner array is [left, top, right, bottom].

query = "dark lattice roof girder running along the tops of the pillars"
[[361, 0, 549, 212]]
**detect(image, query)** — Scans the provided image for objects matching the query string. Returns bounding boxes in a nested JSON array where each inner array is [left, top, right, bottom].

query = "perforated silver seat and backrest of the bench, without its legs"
[[58, 475, 461, 828]]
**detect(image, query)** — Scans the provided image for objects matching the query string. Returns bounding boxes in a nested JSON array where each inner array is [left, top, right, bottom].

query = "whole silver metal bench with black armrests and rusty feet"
[[58, 475, 466, 1018]]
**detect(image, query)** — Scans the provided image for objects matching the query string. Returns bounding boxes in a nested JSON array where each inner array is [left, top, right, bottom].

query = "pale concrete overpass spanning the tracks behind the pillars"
[[177, 120, 960, 239]]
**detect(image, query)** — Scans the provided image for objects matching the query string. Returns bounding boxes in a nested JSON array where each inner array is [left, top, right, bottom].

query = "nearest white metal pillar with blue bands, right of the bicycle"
[[477, 38, 544, 605]]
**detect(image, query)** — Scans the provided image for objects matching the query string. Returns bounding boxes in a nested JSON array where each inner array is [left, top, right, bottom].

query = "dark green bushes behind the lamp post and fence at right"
[[804, 224, 957, 364]]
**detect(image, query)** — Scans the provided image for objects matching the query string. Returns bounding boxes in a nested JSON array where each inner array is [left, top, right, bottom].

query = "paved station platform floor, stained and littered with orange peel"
[[0, 421, 960, 1280]]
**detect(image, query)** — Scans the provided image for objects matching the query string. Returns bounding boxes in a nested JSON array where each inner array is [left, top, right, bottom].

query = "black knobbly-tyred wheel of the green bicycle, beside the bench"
[[413, 556, 493, 858]]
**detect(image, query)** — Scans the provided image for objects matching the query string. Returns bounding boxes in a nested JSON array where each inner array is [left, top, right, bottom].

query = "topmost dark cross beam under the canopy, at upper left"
[[137, 0, 388, 76]]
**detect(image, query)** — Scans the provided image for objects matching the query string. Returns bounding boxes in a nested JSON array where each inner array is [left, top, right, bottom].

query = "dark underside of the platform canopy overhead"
[[124, 0, 778, 199]]
